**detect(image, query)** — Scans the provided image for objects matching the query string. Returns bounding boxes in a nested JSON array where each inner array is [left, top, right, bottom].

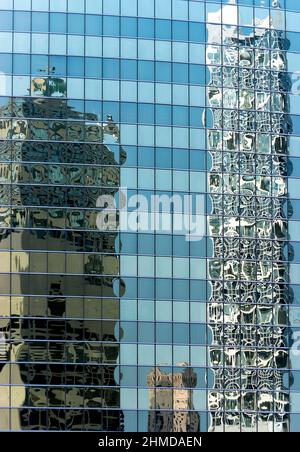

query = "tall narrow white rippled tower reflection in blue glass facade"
[[207, 6, 291, 431]]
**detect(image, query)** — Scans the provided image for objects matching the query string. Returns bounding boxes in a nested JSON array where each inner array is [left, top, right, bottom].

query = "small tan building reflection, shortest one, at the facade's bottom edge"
[[147, 367, 200, 432]]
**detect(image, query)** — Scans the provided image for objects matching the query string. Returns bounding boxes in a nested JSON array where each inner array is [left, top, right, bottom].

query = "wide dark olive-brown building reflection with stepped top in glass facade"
[[0, 78, 125, 431]]
